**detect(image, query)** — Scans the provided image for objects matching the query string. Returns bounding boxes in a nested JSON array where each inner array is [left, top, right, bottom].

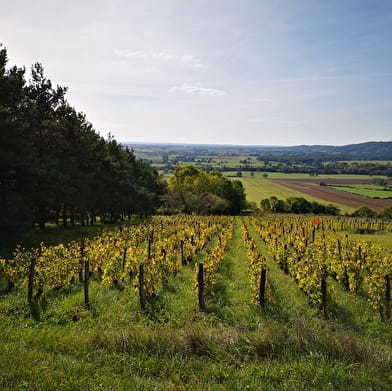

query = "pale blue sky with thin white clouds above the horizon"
[[0, 0, 392, 145]]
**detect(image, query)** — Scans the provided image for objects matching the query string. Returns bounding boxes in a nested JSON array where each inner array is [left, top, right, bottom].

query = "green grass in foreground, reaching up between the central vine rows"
[[0, 218, 392, 391]]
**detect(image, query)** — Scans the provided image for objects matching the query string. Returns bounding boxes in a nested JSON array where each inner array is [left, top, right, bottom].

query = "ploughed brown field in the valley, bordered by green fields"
[[273, 178, 392, 211]]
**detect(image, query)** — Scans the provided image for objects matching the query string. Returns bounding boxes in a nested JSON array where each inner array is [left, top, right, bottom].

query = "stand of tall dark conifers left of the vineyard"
[[0, 44, 166, 231]]
